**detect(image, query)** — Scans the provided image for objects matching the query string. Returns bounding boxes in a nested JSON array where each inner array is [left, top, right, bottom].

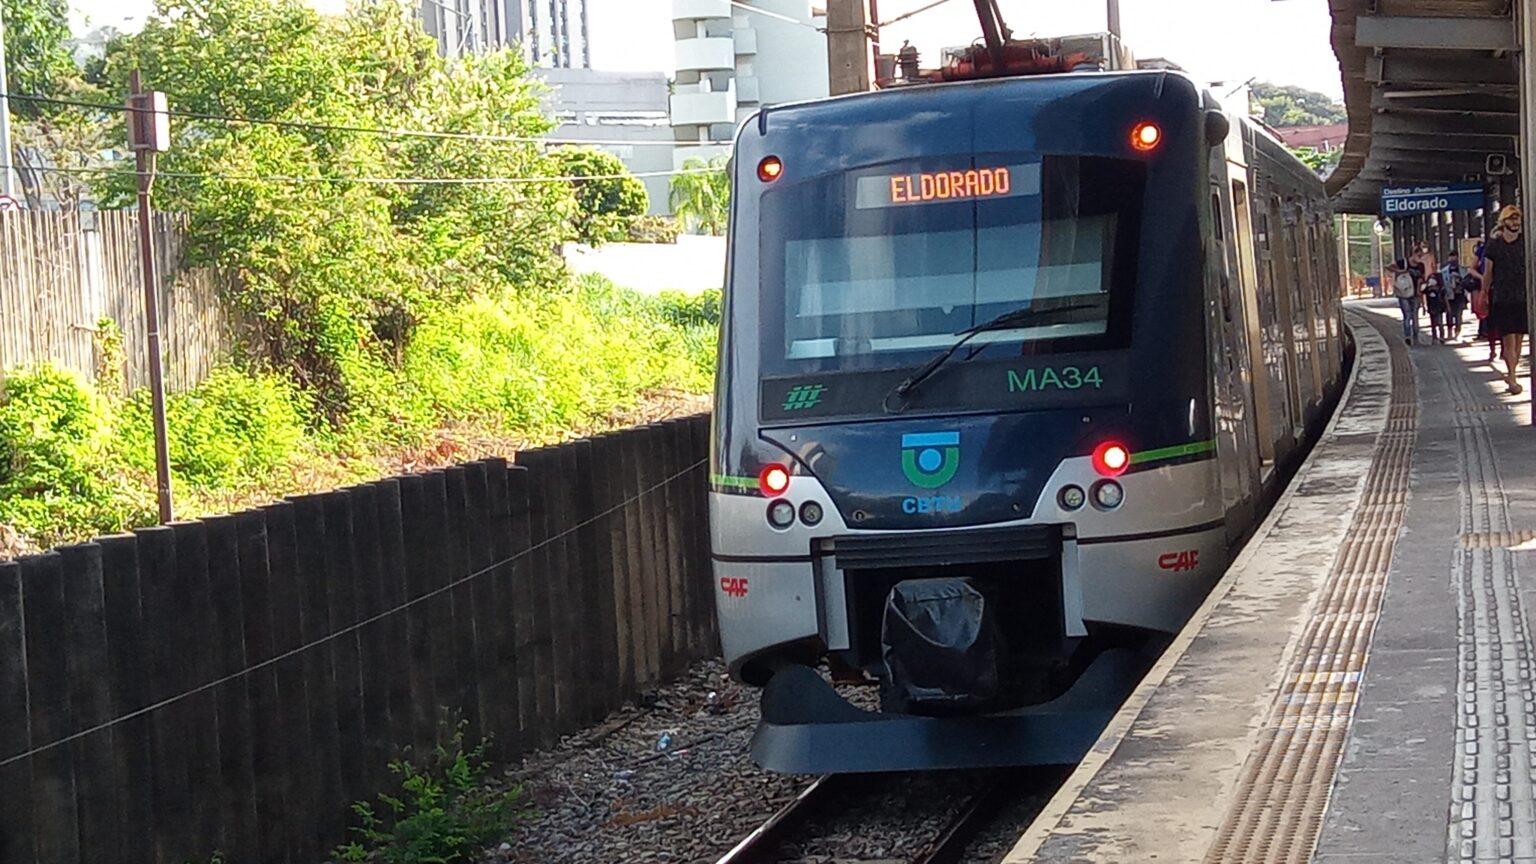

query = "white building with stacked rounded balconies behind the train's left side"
[[671, 0, 828, 168]]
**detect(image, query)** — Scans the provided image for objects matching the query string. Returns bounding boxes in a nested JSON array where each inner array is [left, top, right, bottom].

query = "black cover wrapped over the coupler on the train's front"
[[880, 578, 1001, 713]]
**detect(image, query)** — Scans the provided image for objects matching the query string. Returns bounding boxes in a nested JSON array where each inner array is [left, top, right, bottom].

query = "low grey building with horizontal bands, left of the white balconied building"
[[536, 69, 676, 215]]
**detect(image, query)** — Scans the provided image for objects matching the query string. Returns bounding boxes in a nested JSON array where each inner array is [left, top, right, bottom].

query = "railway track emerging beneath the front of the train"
[[716, 772, 1035, 864]]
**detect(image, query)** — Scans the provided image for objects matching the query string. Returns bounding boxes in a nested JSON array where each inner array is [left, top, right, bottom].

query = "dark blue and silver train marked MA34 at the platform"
[[710, 71, 1344, 772]]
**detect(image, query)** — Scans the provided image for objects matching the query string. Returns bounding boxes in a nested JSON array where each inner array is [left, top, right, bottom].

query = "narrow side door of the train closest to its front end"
[[1207, 178, 1258, 522]]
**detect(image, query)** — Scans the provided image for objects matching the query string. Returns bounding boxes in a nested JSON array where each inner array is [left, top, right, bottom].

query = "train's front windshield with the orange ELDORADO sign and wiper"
[[760, 154, 1146, 374]]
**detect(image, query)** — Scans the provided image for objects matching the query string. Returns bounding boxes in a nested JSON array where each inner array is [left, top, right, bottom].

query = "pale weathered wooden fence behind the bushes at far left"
[[0, 211, 232, 390]]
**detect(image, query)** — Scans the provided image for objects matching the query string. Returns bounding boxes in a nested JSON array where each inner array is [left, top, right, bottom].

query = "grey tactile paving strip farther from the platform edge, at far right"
[[1445, 342, 1536, 864]]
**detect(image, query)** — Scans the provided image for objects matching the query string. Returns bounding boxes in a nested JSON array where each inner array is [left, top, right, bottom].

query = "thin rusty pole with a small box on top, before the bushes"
[[127, 69, 174, 524]]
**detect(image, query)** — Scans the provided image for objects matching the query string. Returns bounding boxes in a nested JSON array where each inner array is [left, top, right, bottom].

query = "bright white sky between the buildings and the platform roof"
[[71, 0, 1344, 98]]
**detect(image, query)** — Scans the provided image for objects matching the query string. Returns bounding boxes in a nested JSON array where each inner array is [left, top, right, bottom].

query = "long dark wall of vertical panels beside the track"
[[0, 417, 717, 864]]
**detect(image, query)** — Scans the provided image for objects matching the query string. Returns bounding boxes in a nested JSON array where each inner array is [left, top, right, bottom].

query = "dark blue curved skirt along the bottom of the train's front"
[[751, 649, 1157, 773]]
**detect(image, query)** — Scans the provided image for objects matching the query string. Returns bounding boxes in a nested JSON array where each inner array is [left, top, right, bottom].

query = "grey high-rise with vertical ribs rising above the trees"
[[421, 0, 591, 69]]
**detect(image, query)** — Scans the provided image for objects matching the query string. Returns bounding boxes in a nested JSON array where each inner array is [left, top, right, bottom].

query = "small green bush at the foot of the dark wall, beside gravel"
[[335, 724, 525, 864]]
